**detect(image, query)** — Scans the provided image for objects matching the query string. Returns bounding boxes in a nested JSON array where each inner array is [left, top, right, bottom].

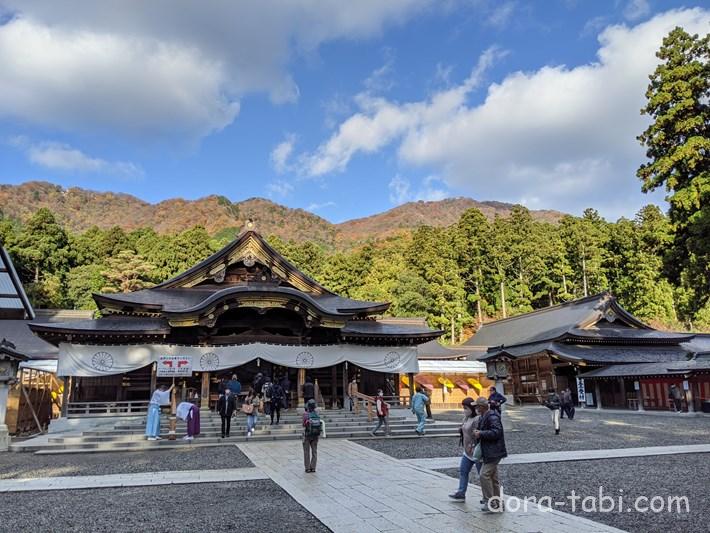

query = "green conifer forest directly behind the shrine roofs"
[[0, 202, 710, 341]]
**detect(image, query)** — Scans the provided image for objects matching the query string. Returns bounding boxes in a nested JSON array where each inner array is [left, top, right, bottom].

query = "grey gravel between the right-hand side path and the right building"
[[358, 407, 710, 459]]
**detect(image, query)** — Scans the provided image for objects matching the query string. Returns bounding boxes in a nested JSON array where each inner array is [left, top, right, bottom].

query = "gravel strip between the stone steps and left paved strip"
[[0, 446, 254, 480]]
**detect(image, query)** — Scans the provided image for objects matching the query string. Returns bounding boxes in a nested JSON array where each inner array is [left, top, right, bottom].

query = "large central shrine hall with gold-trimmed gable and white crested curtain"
[[30, 230, 443, 407]]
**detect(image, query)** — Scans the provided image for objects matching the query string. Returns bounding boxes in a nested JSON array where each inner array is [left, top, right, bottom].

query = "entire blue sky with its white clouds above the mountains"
[[0, 0, 710, 222]]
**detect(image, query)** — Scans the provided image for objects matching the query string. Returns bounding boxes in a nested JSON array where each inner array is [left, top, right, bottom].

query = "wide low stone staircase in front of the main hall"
[[10, 410, 458, 454]]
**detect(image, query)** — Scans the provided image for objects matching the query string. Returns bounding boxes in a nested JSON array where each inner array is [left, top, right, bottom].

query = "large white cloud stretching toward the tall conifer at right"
[[302, 8, 710, 217]]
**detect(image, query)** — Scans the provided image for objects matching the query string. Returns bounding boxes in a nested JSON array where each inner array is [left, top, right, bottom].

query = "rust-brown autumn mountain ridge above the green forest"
[[0, 181, 564, 248]]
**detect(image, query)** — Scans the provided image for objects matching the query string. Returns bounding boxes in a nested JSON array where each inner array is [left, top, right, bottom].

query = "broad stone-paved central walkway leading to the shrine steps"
[[237, 440, 620, 533]]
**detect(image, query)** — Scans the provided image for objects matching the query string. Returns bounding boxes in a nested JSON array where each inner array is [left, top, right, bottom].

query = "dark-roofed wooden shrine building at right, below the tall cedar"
[[466, 292, 710, 411]]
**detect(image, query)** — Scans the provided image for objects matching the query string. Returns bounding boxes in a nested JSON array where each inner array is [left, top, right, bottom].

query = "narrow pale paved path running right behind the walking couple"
[[404, 444, 710, 470]]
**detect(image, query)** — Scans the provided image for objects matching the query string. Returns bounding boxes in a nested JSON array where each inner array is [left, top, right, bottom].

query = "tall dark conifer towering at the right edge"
[[637, 28, 710, 312]]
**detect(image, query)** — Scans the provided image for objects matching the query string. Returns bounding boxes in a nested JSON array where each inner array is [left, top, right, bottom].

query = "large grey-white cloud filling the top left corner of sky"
[[0, 0, 434, 139]]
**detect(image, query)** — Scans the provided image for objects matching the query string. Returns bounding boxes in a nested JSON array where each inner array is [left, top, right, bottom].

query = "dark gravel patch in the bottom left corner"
[[0, 480, 330, 533]]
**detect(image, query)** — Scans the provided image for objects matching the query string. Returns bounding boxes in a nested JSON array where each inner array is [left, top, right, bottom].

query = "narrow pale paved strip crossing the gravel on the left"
[[0, 468, 268, 493]]
